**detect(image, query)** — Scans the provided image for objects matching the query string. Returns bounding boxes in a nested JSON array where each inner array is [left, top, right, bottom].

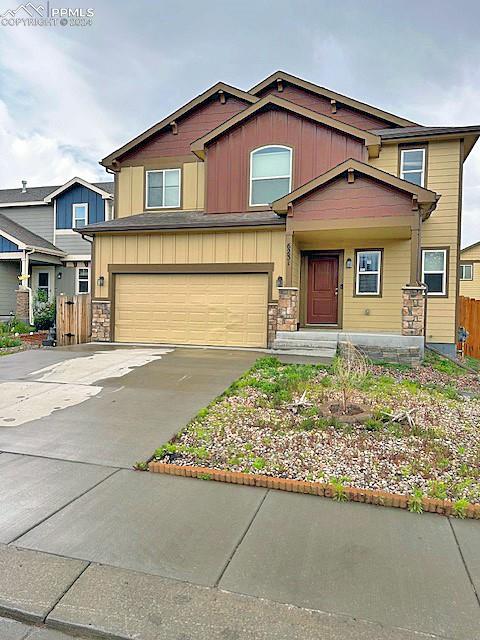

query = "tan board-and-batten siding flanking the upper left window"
[[115, 161, 205, 218]]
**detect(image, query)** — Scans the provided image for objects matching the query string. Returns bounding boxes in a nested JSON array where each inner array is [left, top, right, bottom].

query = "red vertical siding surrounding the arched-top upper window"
[[207, 109, 366, 213]]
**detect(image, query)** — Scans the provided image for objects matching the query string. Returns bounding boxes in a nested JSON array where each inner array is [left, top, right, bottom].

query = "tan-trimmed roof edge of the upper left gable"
[[100, 82, 258, 167]]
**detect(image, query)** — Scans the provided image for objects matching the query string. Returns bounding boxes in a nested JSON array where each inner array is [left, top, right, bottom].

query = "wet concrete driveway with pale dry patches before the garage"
[[0, 345, 258, 468]]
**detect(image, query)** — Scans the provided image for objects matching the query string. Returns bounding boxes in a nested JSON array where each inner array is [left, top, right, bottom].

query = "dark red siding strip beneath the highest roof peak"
[[259, 84, 393, 130]]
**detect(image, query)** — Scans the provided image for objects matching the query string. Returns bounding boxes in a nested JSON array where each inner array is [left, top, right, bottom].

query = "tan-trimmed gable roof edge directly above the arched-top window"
[[190, 95, 381, 159]]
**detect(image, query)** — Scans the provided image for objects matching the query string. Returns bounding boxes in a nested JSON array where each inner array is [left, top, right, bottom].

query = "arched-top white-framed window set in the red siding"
[[249, 145, 292, 207]]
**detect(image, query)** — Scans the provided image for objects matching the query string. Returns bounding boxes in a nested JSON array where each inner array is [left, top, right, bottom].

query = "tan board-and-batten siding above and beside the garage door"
[[93, 230, 285, 298]]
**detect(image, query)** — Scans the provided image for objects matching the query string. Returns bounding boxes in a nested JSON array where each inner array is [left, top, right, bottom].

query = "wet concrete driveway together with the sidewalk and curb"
[[0, 345, 480, 640]]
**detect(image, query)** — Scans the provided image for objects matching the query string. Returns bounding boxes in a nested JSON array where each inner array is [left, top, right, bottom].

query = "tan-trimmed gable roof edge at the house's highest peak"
[[249, 71, 416, 127]]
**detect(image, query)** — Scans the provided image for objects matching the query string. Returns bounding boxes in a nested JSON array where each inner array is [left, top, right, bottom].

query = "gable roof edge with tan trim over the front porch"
[[271, 158, 440, 216]]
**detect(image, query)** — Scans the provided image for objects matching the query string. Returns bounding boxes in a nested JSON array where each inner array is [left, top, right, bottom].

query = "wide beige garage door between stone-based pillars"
[[115, 273, 268, 347]]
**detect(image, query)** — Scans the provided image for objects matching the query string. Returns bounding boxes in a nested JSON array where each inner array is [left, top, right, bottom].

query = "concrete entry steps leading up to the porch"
[[273, 329, 338, 360]]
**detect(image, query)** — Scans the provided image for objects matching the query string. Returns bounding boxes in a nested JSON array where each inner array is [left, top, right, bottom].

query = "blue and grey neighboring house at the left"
[[0, 178, 113, 320]]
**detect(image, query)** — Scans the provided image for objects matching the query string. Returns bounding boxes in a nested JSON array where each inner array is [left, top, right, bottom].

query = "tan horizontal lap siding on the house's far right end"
[[370, 140, 462, 343]]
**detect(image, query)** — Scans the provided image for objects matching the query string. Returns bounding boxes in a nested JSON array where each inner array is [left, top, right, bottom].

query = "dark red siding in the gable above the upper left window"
[[120, 96, 248, 164]]
